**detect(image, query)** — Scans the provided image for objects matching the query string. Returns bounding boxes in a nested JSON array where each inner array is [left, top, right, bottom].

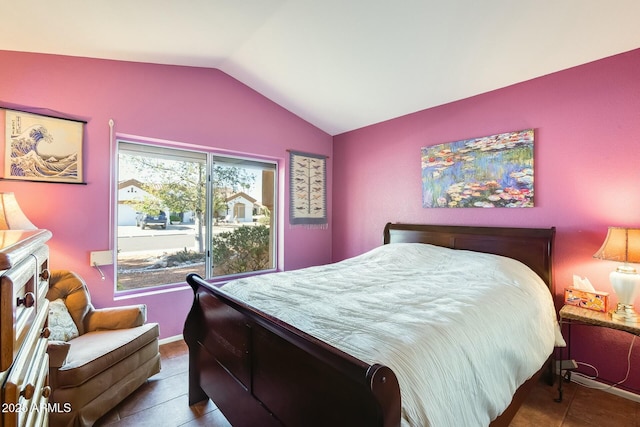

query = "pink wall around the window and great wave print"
[[0, 51, 333, 337]]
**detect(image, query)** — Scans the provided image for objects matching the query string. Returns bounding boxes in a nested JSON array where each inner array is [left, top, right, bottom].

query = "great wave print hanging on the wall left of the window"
[[0, 109, 85, 184]]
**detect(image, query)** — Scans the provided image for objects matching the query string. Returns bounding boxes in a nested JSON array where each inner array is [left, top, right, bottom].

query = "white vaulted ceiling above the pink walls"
[[0, 0, 640, 135]]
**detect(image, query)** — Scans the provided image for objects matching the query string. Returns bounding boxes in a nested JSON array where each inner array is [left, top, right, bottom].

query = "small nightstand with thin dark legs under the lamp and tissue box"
[[556, 305, 640, 402]]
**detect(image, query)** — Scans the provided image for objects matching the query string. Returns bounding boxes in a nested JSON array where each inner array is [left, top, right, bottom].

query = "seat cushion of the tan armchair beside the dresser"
[[57, 323, 159, 388]]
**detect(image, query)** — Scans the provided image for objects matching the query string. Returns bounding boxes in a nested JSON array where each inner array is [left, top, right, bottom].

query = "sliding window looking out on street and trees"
[[116, 141, 277, 291]]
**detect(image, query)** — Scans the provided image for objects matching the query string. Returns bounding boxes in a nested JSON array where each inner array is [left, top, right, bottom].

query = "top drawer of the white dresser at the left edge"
[[0, 256, 38, 371]]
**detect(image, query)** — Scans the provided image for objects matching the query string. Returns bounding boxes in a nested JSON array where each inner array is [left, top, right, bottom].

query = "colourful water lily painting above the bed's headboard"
[[422, 129, 534, 208]]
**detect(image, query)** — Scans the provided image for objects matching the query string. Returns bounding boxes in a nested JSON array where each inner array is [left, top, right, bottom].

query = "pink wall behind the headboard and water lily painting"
[[333, 50, 640, 392]]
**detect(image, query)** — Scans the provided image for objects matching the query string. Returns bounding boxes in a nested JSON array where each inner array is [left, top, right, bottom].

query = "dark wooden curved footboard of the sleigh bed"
[[184, 274, 400, 426]]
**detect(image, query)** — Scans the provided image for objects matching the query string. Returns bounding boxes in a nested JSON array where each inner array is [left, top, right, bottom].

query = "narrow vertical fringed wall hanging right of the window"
[[289, 151, 327, 228]]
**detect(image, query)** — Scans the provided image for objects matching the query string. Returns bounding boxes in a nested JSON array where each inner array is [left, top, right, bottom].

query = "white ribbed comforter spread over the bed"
[[222, 243, 562, 426]]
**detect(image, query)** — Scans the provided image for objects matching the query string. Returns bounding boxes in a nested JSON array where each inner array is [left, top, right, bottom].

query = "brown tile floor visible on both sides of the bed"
[[96, 341, 640, 427]]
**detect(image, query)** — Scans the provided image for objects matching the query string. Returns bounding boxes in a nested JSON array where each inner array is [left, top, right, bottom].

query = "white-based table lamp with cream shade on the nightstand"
[[593, 227, 640, 322]]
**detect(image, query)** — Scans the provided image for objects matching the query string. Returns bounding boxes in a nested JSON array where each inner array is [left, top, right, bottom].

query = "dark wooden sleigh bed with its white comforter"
[[184, 223, 561, 426]]
